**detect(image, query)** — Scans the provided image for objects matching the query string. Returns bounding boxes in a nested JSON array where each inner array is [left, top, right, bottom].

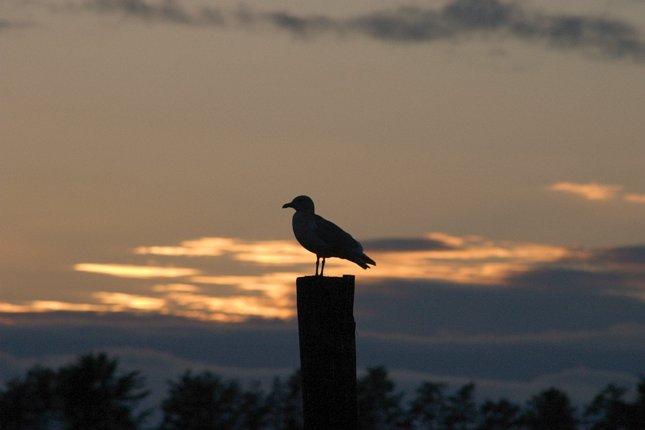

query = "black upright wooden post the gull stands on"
[[297, 275, 357, 430]]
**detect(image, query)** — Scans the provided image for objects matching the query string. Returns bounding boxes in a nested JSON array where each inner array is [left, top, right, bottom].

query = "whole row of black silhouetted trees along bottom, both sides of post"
[[0, 353, 645, 430]]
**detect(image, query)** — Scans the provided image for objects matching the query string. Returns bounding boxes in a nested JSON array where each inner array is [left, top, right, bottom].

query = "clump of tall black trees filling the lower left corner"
[[0, 353, 148, 430]]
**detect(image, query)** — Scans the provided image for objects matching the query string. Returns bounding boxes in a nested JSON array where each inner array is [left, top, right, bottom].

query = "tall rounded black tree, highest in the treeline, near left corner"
[[56, 353, 148, 430]]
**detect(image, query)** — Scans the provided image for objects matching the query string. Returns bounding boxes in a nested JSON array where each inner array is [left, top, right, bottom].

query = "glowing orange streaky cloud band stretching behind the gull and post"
[[0, 233, 645, 322]]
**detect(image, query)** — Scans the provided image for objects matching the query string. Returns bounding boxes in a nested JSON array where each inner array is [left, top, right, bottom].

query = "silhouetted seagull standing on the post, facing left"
[[282, 196, 376, 276]]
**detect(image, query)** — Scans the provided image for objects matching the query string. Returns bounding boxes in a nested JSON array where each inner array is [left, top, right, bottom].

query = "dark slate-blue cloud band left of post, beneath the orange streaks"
[[0, 312, 298, 369]]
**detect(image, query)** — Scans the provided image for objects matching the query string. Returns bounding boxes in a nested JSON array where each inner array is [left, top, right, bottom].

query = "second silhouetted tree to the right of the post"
[[408, 382, 446, 430]]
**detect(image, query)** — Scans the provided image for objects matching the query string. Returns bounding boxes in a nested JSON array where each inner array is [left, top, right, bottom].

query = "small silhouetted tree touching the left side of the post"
[[267, 370, 303, 430]]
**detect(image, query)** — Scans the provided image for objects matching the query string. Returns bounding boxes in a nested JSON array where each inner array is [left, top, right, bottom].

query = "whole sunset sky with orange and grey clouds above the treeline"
[[0, 0, 645, 414]]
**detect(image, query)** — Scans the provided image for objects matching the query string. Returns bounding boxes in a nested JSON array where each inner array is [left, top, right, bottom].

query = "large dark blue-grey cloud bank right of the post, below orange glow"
[[356, 239, 645, 366]]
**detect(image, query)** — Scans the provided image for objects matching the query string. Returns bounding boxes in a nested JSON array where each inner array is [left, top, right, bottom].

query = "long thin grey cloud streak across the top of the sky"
[[78, 0, 645, 61]]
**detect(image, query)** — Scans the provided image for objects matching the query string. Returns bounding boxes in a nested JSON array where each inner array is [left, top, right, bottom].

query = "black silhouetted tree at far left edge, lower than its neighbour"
[[0, 366, 60, 430]]
